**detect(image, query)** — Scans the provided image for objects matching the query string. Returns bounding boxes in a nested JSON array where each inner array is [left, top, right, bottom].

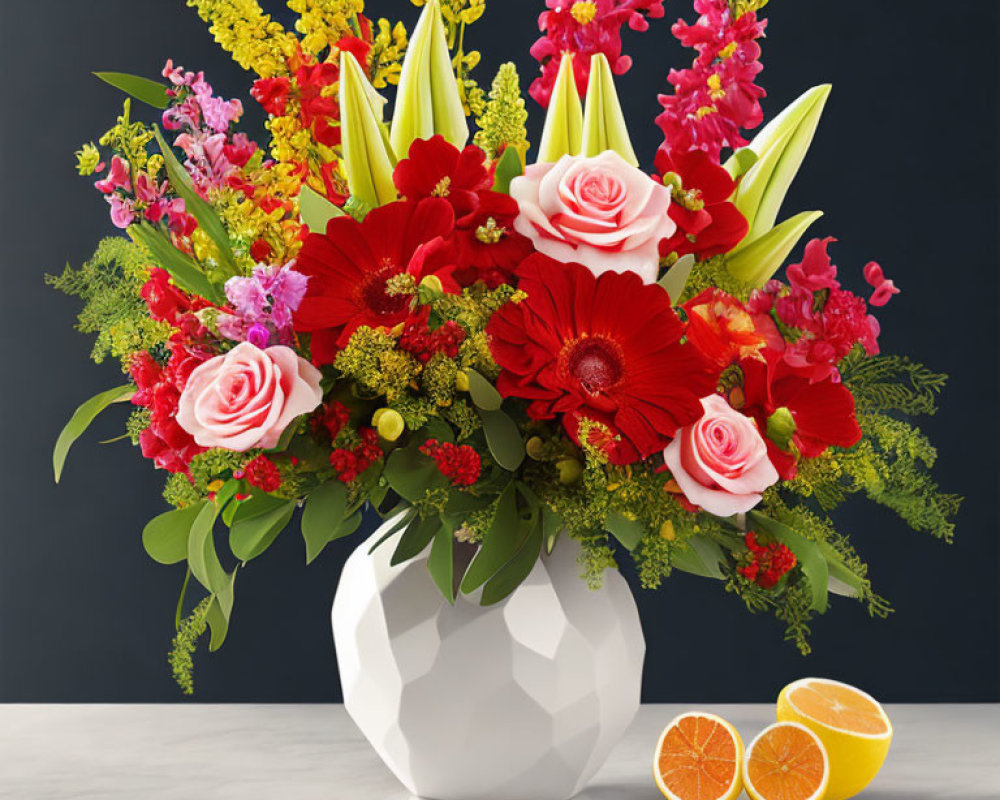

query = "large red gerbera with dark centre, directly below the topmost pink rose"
[[487, 254, 719, 463]]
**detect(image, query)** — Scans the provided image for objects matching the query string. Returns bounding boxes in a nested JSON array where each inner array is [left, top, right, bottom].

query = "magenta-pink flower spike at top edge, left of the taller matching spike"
[[528, 0, 665, 107]]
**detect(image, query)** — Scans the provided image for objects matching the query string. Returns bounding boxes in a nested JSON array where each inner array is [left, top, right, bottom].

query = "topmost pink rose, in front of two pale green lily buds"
[[510, 150, 677, 283]]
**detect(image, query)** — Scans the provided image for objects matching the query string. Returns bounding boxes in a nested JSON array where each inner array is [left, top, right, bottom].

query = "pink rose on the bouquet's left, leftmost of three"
[[177, 342, 323, 452]]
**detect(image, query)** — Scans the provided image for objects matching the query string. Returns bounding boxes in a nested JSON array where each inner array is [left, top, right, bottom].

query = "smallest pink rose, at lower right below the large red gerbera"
[[663, 394, 778, 517]]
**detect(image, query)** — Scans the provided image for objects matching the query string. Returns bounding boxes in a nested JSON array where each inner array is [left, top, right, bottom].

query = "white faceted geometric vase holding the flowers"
[[333, 520, 645, 800]]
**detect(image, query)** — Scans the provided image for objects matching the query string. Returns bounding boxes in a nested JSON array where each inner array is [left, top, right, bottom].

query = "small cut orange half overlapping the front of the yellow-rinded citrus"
[[743, 722, 830, 800]]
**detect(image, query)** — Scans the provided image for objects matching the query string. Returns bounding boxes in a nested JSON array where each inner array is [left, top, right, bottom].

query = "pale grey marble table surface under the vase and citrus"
[[0, 705, 1000, 800]]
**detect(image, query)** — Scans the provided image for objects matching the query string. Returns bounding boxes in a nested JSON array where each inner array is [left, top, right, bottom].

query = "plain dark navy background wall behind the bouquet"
[[0, 0, 1000, 702]]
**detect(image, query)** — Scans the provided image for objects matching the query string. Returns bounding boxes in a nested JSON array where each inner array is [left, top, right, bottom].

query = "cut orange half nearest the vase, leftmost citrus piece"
[[653, 711, 743, 800]]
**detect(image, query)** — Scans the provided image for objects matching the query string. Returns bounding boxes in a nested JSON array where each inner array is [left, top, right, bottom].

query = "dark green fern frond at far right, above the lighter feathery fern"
[[840, 347, 948, 415]]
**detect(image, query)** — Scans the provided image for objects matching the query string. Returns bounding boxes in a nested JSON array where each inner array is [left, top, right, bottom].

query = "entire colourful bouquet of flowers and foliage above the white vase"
[[50, 0, 958, 796]]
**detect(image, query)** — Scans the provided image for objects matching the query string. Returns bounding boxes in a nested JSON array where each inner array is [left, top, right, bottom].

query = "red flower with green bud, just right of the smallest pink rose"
[[730, 352, 861, 480]]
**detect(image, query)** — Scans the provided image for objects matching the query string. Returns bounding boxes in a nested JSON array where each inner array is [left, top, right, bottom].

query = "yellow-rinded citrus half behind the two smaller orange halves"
[[778, 678, 892, 800]]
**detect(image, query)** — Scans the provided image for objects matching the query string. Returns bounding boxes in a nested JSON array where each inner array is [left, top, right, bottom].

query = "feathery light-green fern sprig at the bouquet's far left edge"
[[45, 237, 170, 365]]
